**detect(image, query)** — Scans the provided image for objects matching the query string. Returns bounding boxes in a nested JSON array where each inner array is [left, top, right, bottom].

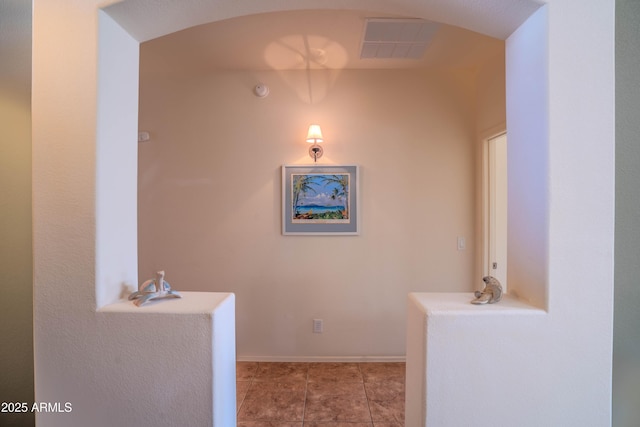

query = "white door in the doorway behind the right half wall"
[[487, 133, 507, 291]]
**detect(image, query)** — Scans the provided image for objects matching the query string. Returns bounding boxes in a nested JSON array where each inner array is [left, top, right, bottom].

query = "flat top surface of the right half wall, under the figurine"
[[409, 292, 547, 316]]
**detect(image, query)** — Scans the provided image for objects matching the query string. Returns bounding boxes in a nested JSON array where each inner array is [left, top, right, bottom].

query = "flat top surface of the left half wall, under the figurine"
[[98, 292, 234, 314]]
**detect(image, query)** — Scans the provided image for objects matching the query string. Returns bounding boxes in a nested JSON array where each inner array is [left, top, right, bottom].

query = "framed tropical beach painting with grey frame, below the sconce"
[[282, 165, 360, 235]]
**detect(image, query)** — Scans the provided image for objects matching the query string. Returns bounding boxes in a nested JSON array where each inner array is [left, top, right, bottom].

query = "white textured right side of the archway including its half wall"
[[407, 0, 616, 427]]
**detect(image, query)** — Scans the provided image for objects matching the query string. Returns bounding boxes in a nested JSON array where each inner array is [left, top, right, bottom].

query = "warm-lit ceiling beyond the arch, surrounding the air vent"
[[141, 10, 504, 72]]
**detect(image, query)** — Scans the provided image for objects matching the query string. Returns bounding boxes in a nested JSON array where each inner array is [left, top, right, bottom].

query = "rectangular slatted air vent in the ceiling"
[[360, 18, 440, 59]]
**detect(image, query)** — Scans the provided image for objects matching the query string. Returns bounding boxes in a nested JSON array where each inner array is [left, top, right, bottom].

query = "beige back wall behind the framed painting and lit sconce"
[[138, 68, 484, 358]]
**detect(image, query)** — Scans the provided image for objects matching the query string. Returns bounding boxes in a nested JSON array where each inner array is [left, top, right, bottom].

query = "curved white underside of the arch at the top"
[[103, 0, 547, 42]]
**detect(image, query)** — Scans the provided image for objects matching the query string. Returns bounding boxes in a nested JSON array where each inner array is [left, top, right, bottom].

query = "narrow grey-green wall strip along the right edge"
[[613, 0, 640, 427]]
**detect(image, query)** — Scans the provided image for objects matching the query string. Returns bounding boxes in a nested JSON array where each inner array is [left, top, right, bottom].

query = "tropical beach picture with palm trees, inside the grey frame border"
[[291, 173, 351, 224]]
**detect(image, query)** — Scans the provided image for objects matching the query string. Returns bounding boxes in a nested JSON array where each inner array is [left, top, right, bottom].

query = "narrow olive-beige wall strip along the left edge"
[[0, 0, 34, 426]]
